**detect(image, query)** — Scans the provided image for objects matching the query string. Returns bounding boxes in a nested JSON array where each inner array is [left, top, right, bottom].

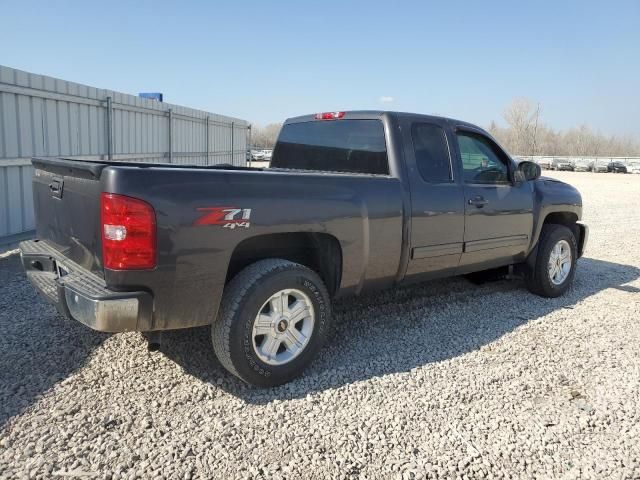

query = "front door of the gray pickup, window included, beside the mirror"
[[456, 128, 533, 271]]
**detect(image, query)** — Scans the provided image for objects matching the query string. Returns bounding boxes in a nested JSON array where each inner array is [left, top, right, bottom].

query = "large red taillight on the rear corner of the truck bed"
[[101, 193, 156, 270]]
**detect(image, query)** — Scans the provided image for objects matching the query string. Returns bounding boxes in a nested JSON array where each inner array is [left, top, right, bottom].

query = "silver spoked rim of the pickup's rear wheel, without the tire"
[[252, 289, 315, 365]]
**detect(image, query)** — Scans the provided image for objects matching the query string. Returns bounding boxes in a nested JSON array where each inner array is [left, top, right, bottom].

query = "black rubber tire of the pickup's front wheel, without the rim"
[[525, 224, 578, 298]]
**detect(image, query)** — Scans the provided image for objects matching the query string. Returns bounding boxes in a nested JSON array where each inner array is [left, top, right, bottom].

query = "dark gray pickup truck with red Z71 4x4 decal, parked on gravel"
[[21, 111, 588, 386]]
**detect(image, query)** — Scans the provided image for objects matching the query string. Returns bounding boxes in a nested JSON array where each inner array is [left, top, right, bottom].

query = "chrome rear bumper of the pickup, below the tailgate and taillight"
[[20, 240, 153, 332]]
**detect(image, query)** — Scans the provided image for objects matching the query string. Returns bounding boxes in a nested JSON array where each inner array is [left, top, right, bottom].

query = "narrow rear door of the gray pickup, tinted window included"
[[402, 119, 464, 281]]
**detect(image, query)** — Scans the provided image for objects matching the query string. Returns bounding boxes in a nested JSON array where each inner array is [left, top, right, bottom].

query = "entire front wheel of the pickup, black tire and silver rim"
[[525, 224, 578, 297]]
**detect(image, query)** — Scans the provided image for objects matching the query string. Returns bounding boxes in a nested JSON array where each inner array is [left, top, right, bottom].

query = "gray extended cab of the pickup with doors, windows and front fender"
[[271, 112, 584, 283]]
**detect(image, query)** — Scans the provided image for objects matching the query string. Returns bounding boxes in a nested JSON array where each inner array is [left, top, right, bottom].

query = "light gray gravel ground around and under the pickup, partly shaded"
[[0, 172, 640, 479]]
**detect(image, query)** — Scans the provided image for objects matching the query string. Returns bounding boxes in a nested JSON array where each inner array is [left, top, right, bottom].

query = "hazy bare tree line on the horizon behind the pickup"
[[251, 98, 640, 157]]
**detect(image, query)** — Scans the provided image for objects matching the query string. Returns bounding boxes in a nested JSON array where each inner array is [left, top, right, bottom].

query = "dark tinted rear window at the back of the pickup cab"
[[271, 120, 389, 175]]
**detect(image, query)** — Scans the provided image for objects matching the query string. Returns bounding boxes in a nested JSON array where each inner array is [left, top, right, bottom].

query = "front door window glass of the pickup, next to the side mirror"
[[457, 132, 509, 184]]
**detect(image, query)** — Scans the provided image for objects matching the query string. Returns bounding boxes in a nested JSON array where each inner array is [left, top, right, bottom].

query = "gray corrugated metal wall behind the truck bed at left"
[[0, 65, 248, 245]]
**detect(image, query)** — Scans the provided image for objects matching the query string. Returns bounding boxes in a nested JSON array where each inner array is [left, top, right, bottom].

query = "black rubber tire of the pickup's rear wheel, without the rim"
[[211, 258, 331, 387]]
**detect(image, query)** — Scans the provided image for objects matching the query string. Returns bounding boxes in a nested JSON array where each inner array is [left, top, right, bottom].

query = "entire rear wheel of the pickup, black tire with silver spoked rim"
[[211, 259, 331, 387]]
